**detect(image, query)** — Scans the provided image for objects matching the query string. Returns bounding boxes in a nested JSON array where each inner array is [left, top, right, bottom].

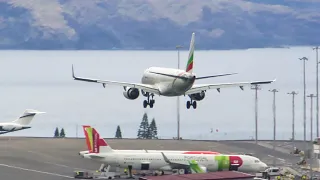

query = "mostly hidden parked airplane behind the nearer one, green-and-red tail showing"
[[79, 125, 220, 156]]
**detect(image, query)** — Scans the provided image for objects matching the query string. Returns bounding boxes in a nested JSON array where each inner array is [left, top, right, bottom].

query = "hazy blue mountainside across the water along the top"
[[0, 0, 320, 50]]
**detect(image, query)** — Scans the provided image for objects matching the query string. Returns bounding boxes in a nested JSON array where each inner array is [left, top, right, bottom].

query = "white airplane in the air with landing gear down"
[[72, 33, 275, 109]]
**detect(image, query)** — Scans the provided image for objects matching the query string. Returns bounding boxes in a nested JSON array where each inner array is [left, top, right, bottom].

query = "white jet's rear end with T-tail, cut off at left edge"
[[0, 109, 45, 134]]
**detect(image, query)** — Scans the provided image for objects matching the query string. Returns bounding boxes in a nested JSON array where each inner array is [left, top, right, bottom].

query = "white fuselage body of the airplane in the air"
[[141, 67, 195, 96]]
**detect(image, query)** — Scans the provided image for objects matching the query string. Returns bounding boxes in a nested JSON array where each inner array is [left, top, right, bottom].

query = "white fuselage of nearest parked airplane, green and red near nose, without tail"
[[84, 152, 267, 172]]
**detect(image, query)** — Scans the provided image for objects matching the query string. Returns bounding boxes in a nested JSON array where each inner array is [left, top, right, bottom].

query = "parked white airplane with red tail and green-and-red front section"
[[83, 126, 268, 173]]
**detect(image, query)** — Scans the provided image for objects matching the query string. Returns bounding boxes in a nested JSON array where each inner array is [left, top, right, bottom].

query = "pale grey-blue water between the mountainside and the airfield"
[[0, 47, 316, 139]]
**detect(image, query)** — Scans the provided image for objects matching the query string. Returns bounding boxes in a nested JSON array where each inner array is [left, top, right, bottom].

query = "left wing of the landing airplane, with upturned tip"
[[72, 66, 160, 95]]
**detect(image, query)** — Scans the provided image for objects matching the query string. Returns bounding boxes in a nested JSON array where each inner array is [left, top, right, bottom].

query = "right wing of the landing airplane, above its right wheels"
[[185, 80, 276, 95]]
